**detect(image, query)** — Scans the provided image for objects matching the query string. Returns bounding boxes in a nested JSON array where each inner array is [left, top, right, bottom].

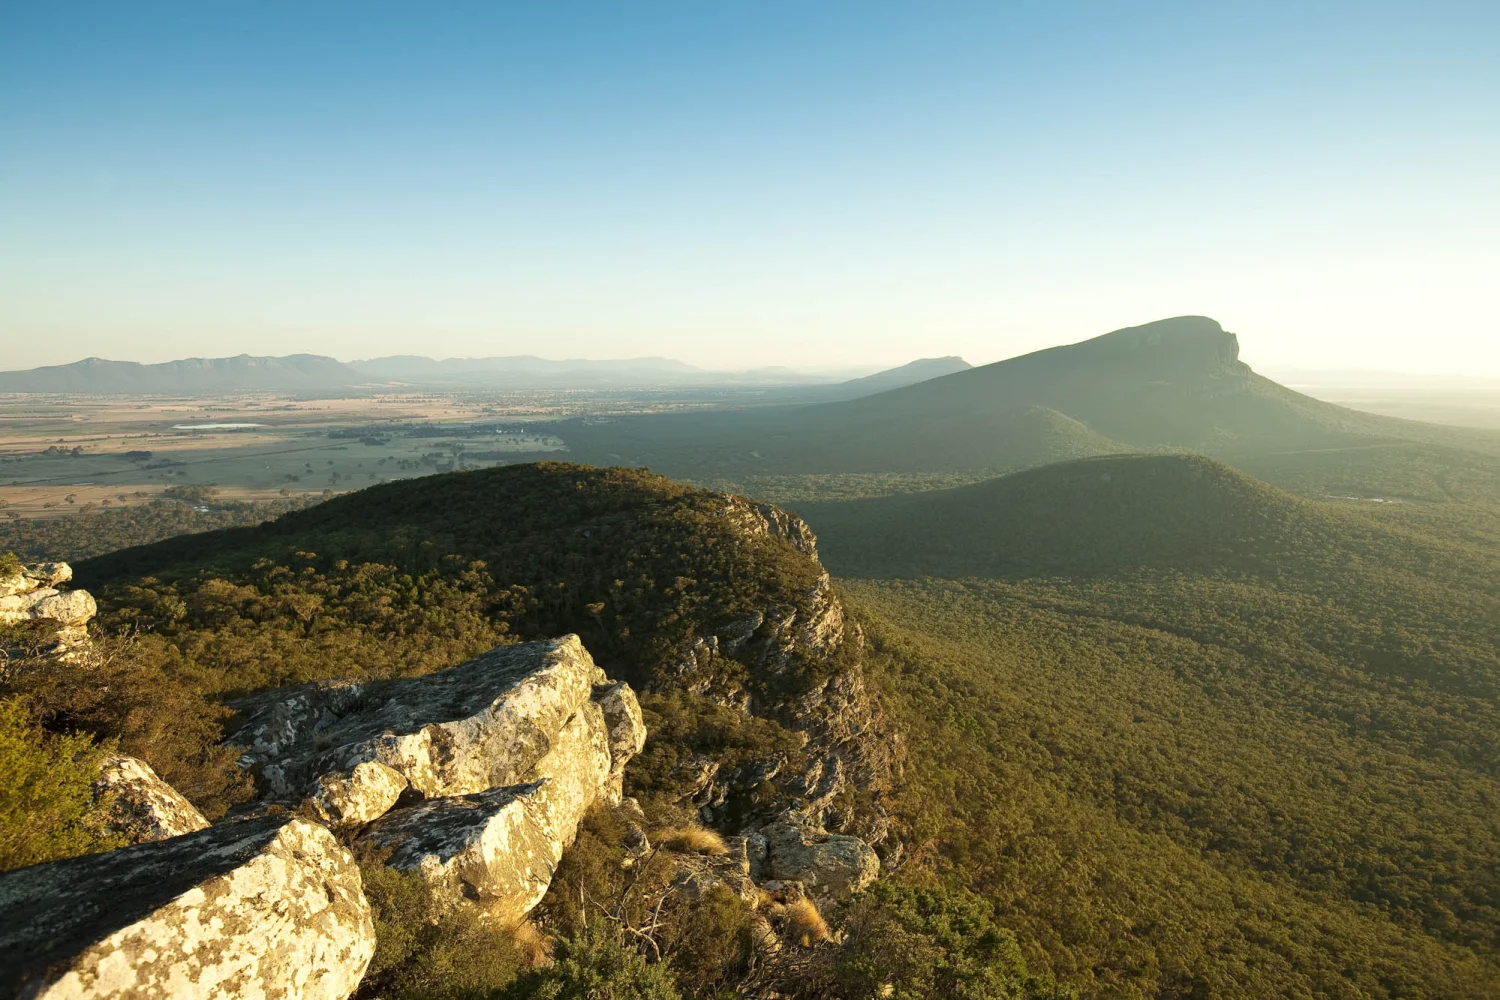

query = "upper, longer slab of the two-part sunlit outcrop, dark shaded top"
[[230, 636, 644, 825]]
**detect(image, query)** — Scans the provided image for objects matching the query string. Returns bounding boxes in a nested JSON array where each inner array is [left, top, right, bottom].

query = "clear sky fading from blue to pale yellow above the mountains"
[[0, 0, 1500, 373]]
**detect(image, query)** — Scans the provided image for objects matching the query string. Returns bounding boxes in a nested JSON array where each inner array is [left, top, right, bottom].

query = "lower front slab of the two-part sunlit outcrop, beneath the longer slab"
[[360, 688, 615, 927]]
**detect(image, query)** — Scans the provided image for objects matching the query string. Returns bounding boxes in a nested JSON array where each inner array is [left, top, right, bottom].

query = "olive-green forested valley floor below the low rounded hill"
[[846, 579, 1500, 1000]]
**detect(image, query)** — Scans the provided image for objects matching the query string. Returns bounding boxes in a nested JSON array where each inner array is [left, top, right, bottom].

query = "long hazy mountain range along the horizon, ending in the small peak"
[[0, 354, 969, 400]]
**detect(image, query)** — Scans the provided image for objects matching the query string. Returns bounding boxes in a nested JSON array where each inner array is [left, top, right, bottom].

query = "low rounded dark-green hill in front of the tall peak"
[[798, 454, 1500, 595]]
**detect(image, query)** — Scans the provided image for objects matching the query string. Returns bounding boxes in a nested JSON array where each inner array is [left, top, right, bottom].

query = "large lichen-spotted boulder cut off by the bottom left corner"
[[0, 816, 375, 1000]]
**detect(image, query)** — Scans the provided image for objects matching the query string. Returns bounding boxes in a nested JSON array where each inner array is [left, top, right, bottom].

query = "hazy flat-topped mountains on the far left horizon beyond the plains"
[[0, 354, 368, 394]]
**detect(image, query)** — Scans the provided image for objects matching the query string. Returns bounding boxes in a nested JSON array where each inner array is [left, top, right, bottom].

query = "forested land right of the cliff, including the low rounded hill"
[[800, 456, 1500, 997]]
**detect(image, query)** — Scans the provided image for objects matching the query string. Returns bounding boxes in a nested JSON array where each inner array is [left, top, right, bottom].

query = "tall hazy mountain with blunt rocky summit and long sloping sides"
[[560, 316, 1500, 497]]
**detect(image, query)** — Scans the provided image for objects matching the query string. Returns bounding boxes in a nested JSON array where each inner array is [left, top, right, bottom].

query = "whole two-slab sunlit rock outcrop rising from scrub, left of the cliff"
[[233, 636, 645, 924]]
